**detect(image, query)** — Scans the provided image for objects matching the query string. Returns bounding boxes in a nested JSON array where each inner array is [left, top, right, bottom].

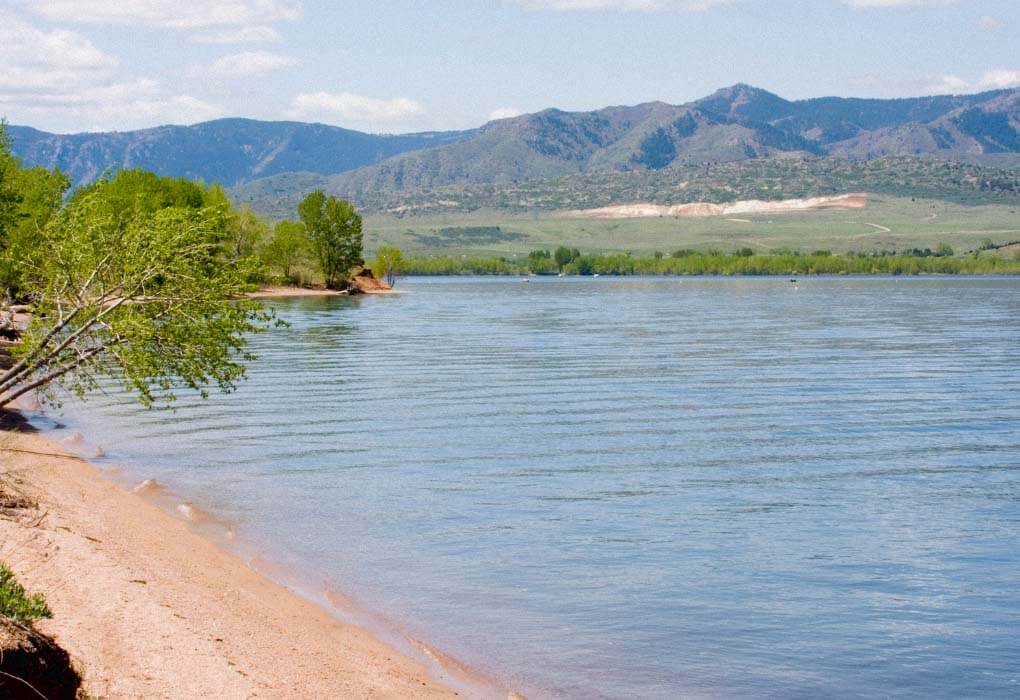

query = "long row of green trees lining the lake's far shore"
[[401, 249, 1020, 276]]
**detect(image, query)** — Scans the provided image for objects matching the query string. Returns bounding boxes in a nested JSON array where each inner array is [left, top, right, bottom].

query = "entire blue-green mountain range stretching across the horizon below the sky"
[[8, 85, 1020, 214]]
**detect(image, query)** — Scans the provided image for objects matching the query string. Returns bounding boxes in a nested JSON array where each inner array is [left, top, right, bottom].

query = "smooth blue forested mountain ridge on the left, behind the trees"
[[7, 119, 473, 187]]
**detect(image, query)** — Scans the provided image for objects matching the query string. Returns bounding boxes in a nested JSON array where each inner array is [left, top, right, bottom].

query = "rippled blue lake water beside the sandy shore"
[[45, 278, 1020, 698]]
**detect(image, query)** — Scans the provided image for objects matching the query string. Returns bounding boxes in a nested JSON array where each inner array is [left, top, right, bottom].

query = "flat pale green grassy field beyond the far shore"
[[365, 197, 1020, 257]]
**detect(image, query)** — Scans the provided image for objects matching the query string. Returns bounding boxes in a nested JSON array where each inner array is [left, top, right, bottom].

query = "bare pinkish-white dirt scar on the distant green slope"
[[562, 192, 868, 218]]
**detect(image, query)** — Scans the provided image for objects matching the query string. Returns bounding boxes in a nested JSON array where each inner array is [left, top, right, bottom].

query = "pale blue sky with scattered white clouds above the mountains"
[[0, 0, 1020, 133]]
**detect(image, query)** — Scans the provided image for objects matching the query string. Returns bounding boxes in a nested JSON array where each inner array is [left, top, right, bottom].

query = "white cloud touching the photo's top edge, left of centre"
[[22, 0, 301, 30]]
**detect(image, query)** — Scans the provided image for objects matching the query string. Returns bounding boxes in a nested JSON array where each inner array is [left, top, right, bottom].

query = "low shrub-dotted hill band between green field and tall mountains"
[[231, 155, 1020, 218]]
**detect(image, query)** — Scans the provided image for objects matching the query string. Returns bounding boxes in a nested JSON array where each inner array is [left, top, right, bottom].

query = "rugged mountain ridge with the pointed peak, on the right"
[[330, 85, 1020, 193]]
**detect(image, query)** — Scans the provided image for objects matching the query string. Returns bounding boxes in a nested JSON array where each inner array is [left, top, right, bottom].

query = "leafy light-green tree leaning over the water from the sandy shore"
[[0, 176, 270, 414]]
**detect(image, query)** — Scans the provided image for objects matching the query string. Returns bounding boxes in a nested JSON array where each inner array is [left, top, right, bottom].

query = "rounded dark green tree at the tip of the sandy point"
[[298, 190, 362, 289]]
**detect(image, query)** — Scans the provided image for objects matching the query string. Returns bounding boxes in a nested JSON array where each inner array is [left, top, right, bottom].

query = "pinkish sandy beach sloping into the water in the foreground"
[[0, 420, 507, 698]]
